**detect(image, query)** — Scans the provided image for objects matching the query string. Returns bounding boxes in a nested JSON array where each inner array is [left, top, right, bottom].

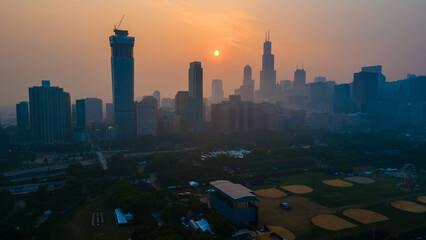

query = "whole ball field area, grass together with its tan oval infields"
[[256, 173, 426, 239]]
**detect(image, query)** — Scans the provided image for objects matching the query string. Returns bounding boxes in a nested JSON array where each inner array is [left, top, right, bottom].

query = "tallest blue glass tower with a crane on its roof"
[[109, 29, 135, 139]]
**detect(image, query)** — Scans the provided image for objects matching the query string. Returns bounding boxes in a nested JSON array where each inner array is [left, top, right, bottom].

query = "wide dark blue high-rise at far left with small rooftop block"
[[29, 81, 64, 144]]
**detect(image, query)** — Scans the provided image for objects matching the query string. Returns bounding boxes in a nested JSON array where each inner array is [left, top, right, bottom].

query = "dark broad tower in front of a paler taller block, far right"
[[352, 72, 379, 113]]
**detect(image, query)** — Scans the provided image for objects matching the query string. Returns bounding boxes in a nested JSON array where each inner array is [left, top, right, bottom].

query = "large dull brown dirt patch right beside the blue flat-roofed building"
[[259, 195, 334, 231]]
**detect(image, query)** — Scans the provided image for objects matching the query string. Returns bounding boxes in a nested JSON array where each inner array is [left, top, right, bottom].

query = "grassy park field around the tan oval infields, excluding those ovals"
[[254, 172, 426, 239]]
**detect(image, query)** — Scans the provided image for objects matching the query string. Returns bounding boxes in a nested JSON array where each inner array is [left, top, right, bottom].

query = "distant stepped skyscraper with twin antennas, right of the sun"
[[260, 32, 277, 99]]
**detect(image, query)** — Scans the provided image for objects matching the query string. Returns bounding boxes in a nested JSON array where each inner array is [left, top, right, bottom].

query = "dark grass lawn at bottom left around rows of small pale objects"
[[42, 198, 135, 240]]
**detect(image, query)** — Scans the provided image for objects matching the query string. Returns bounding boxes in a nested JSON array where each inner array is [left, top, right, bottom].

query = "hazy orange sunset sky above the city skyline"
[[0, 0, 426, 106]]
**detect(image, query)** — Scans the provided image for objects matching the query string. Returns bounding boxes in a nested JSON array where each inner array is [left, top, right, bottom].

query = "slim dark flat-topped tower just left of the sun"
[[188, 62, 203, 130]]
